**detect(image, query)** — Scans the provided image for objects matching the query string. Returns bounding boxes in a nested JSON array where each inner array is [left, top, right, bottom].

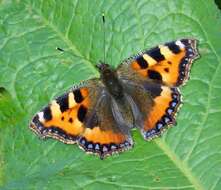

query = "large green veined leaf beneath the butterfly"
[[0, 0, 221, 190]]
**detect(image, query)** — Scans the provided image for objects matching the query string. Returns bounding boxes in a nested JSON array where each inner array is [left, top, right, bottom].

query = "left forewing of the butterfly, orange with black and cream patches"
[[30, 87, 91, 144]]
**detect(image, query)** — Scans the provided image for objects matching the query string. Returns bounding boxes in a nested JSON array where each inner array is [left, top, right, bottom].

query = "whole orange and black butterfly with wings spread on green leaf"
[[30, 39, 199, 159]]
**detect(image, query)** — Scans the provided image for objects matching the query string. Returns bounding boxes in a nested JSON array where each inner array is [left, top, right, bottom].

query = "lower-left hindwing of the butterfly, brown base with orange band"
[[79, 92, 132, 158]]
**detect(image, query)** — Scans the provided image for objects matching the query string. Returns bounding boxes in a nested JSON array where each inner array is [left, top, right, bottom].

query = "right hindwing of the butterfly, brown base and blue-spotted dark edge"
[[123, 80, 181, 140]]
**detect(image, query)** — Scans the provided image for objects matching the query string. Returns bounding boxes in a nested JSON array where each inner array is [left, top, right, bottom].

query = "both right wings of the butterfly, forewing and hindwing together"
[[117, 39, 198, 140]]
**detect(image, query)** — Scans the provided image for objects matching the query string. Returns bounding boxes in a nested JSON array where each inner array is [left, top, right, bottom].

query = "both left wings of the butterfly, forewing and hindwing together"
[[30, 80, 132, 158]]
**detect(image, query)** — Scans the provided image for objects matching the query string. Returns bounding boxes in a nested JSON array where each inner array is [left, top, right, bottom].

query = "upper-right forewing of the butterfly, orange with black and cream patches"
[[129, 39, 198, 86]]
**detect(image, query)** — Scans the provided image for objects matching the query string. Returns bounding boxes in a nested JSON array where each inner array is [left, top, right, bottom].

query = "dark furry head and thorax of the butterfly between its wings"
[[97, 63, 123, 99]]
